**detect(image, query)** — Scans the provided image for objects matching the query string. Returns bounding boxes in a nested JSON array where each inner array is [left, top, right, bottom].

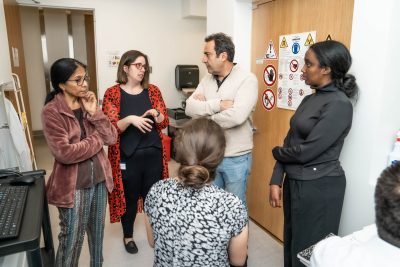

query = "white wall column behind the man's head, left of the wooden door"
[[207, 0, 252, 71]]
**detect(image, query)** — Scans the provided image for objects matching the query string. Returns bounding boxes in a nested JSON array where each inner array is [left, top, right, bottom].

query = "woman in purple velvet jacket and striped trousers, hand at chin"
[[42, 58, 117, 267]]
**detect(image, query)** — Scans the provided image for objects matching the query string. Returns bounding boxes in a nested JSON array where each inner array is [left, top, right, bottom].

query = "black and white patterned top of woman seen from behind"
[[144, 178, 248, 267]]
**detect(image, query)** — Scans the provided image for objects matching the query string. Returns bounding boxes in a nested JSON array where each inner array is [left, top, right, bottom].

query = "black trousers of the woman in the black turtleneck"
[[283, 175, 346, 267]]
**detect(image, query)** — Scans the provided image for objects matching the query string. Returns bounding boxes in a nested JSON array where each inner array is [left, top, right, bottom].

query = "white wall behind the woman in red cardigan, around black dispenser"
[[18, 0, 206, 114]]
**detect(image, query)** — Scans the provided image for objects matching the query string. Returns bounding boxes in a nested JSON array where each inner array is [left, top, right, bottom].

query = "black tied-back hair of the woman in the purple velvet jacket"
[[44, 58, 86, 105]]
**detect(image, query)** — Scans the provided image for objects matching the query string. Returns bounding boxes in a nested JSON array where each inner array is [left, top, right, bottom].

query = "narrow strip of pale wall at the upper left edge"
[[0, 0, 12, 85]]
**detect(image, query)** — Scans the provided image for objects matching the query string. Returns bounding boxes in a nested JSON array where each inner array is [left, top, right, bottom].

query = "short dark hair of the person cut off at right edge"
[[375, 163, 400, 247]]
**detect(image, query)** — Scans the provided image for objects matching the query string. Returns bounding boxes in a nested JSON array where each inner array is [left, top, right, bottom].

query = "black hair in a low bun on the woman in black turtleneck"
[[310, 40, 358, 99]]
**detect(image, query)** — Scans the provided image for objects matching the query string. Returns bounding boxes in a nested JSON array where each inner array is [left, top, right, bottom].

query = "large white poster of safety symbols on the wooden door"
[[278, 31, 317, 110]]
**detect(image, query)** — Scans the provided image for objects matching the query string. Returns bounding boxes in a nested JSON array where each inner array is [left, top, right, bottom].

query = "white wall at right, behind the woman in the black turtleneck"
[[340, 0, 400, 234]]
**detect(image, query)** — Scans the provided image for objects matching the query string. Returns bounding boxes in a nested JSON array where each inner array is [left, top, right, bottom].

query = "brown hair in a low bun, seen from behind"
[[174, 118, 226, 189]]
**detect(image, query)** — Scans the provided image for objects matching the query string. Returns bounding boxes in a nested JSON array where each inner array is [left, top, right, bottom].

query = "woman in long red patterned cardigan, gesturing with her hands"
[[103, 50, 168, 254]]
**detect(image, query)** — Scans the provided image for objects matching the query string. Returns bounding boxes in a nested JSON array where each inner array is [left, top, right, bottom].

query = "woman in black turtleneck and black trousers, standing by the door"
[[269, 41, 358, 267]]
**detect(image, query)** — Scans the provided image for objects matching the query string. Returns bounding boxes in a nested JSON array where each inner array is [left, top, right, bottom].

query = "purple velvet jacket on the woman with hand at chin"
[[42, 94, 118, 208]]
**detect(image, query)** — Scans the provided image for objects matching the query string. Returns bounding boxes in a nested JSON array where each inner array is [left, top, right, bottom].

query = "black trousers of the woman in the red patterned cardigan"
[[121, 147, 163, 238]]
